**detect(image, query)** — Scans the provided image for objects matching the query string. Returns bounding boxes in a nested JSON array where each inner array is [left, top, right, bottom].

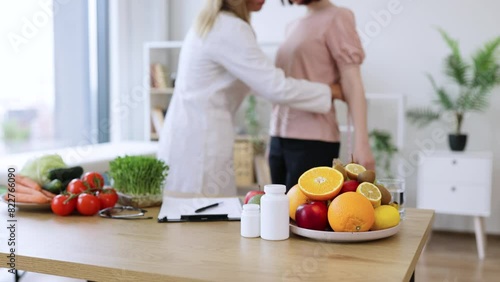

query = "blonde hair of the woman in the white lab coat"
[[195, 0, 250, 37]]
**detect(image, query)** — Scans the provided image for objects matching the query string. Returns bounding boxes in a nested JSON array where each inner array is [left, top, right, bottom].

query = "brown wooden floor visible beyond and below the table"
[[0, 232, 500, 282]]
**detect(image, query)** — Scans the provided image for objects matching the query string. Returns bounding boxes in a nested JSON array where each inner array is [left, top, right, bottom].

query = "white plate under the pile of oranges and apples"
[[290, 222, 401, 242]]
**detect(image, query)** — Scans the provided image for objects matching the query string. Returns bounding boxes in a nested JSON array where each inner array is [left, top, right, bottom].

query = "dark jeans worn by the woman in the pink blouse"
[[269, 137, 340, 192]]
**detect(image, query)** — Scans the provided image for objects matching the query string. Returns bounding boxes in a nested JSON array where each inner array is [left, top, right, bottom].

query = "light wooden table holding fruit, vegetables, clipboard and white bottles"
[[0, 205, 434, 282]]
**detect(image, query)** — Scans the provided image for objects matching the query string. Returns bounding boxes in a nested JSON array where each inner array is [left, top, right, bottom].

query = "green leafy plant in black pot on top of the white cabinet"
[[407, 29, 500, 151]]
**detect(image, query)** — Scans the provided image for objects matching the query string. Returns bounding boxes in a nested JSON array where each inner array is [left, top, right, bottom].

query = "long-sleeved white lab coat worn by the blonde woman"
[[158, 12, 332, 197]]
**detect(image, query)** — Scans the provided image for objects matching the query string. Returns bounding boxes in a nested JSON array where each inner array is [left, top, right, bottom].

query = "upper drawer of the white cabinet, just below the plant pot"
[[419, 157, 491, 184]]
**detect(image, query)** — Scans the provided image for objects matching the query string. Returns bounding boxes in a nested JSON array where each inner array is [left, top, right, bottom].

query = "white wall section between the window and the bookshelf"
[[109, 0, 169, 141]]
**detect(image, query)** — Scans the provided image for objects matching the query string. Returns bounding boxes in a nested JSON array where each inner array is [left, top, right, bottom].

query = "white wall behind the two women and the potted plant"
[[163, 0, 500, 234]]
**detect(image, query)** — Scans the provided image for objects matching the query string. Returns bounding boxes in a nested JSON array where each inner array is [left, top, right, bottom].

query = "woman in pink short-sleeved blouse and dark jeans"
[[269, 0, 375, 189]]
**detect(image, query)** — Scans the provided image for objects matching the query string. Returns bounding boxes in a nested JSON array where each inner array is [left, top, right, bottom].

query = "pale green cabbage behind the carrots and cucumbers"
[[19, 154, 67, 185]]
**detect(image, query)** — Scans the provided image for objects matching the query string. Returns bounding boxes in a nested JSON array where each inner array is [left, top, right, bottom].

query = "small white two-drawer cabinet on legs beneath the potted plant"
[[417, 152, 492, 258]]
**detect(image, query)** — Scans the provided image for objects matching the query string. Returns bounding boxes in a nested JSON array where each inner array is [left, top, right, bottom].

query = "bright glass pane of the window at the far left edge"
[[0, 0, 55, 155]]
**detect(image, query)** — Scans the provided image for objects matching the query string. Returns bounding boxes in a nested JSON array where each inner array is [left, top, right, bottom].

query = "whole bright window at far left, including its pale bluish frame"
[[0, 0, 109, 155]]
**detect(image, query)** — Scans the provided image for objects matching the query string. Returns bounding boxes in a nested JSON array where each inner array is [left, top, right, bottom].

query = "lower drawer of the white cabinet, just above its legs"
[[417, 182, 490, 216]]
